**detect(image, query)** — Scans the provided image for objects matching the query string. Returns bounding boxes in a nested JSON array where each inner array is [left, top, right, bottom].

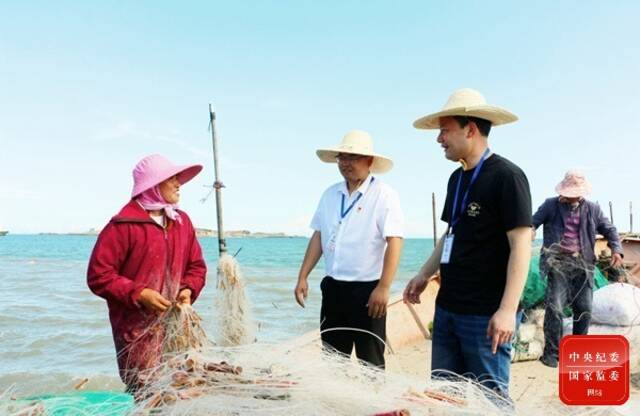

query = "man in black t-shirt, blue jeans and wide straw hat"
[[404, 89, 531, 403]]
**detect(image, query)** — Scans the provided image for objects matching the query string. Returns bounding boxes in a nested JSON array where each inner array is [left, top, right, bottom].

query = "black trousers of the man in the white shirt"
[[320, 276, 387, 368]]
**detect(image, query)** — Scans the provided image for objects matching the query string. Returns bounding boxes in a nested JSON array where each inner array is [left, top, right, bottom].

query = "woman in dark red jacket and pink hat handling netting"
[[87, 155, 207, 393]]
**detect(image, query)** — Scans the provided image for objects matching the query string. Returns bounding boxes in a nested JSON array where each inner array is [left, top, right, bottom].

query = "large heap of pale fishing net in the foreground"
[[126, 307, 510, 415]]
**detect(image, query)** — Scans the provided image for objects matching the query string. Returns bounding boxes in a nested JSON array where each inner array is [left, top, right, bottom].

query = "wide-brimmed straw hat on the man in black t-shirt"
[[413, 88, 518, 130]]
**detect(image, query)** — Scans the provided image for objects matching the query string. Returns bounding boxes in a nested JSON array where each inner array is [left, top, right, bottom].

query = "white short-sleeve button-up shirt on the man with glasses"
[[311, 175, 404, 282]]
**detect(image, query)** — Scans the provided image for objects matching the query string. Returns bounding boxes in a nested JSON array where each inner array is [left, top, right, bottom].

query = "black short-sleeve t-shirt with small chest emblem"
[[436, 154, 531, 315]]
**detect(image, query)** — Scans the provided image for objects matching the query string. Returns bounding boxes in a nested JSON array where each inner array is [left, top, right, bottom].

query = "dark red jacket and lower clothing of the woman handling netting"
[[87, 200, 207, 387]]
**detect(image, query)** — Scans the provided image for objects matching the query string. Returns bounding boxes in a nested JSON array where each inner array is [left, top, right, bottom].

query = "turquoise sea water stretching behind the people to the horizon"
[[0, 234, 433, 394]]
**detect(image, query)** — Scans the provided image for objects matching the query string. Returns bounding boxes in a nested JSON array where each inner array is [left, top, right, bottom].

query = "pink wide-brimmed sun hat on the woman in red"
[[131, 155, 202, 198]]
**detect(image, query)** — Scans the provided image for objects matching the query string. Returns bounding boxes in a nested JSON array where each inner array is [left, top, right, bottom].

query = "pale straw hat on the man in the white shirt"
[[316, 130, 393, 173]]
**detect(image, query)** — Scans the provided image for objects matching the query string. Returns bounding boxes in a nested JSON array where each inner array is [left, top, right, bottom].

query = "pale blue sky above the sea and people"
[[0, 1, 640, 236]]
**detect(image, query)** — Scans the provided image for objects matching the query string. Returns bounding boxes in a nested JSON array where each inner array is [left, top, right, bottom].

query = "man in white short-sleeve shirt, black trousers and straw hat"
[[295, 130, 404, 368]]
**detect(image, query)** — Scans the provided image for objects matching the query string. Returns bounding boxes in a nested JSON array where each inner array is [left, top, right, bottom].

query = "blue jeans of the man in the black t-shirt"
[[431, 306, 522, 400]]
